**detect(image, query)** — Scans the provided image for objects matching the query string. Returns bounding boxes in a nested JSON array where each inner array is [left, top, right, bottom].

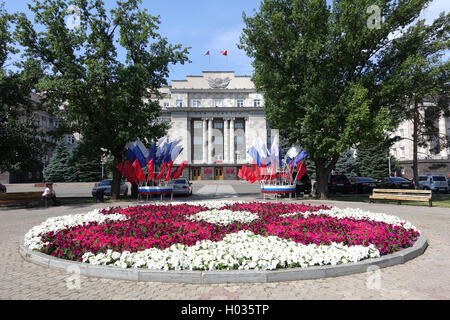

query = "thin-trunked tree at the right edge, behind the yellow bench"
[[378, 13, 450, 189]]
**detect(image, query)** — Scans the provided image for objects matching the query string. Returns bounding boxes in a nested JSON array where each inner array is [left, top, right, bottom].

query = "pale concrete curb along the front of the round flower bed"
[[19, 236, 428, 284]]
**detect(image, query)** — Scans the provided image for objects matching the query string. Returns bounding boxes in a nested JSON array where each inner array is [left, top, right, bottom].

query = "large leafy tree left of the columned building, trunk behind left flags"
[[15, 0, 188, 199]]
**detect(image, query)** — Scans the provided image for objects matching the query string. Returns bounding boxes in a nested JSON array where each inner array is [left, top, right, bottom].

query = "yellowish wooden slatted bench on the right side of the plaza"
[[369, 189, 433, 207]]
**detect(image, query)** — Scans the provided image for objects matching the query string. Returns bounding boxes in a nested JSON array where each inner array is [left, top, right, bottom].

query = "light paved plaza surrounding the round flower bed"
[[0, 195, 450, 300]]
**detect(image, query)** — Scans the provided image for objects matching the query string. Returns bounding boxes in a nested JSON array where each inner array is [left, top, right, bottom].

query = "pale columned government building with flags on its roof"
[[160, 71, 271, 180]]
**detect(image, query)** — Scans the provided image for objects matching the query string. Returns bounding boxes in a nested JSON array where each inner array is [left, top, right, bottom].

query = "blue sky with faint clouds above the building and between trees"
[[4, 0, 450, 80]]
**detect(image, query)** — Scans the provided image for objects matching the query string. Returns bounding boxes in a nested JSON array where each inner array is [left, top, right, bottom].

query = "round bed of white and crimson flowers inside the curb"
[[24, 201, 420, 270]]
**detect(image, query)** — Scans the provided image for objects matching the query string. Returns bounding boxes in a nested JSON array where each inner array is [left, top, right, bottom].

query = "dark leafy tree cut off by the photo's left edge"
[[0, 3, 42, 172]]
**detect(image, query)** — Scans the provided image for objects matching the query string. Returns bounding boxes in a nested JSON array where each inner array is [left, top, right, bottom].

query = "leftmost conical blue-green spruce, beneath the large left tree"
[[44, 140, 76, 182]]
